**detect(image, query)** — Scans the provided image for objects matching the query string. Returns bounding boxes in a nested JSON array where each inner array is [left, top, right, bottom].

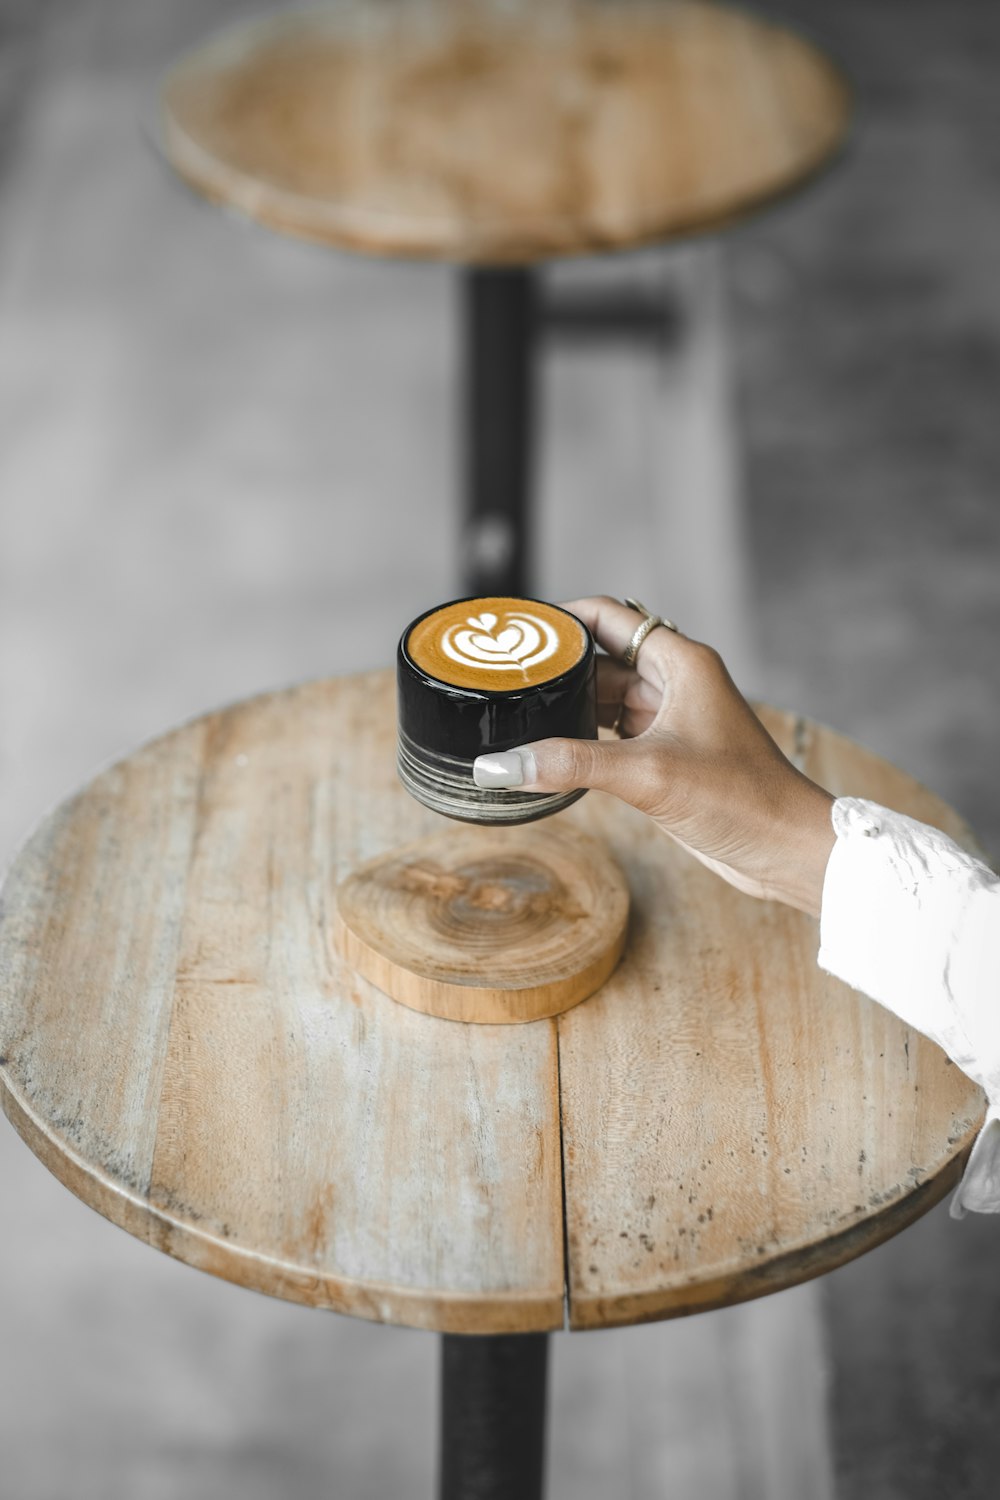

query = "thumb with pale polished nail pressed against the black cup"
[[472, 740, 655, 812]]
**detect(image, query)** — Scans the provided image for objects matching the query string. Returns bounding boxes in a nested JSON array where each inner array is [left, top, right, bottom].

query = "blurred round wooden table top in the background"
[[163, 0, 852, 263]]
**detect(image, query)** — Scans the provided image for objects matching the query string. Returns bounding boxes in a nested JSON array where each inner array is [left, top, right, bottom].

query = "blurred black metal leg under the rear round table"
[[460, 266, 535, 596]]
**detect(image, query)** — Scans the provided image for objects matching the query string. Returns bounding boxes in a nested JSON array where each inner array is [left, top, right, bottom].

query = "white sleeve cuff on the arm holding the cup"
[[819, 797, 1000, 1218]]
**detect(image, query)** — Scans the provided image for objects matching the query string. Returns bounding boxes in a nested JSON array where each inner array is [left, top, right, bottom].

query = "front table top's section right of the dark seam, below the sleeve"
[[559, 710, 984, 1328]]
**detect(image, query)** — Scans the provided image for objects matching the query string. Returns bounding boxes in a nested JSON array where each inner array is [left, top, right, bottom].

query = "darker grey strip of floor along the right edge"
[[746, 0, 1000, 1500]]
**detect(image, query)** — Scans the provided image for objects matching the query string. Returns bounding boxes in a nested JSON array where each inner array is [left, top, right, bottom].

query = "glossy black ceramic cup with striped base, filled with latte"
[[396, 597, 597, 824]]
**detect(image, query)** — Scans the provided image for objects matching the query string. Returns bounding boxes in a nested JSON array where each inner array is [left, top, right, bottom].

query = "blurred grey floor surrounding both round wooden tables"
[[0, 0, 1000, 1500]]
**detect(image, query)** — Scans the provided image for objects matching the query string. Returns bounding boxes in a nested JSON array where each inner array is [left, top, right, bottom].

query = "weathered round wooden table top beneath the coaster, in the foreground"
[[0, 674, 984, 1332]]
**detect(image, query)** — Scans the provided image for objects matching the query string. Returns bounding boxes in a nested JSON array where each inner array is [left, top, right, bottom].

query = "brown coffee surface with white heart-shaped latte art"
[[406, 597, 589, 693]]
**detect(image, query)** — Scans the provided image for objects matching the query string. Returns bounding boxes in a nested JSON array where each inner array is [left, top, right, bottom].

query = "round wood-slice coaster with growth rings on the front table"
[[336, 822, 628, 1023]]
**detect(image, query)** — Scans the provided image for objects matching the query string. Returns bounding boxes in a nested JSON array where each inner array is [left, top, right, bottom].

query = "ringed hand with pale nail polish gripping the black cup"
[[475, 599, 835, 915]]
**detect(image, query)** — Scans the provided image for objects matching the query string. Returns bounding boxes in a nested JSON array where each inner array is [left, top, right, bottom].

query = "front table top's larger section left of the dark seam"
[[0, 677, 562, 1331]]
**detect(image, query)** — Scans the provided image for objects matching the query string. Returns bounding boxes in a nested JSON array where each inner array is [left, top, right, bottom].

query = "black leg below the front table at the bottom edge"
[[439, 1334, 549, 1500]]
